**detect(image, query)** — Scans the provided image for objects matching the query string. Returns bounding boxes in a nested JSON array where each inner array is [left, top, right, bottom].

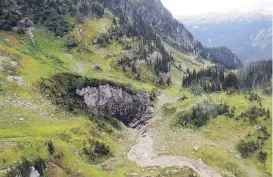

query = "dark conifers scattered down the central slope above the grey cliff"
[[105, 7, 172, 85]]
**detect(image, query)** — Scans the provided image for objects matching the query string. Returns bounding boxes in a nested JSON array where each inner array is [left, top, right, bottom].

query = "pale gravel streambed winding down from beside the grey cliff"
[[127, 95, 221, 177]]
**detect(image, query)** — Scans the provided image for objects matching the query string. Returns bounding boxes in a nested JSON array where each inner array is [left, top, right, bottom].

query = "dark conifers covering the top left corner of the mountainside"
[[0, 0, 104, 36]]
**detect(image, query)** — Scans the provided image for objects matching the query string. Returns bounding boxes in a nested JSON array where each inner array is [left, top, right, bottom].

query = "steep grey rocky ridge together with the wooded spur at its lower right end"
[[103, 0, 241, 68]]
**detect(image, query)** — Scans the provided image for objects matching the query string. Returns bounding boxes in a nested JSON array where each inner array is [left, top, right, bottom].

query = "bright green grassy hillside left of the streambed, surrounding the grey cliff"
[[0, 13, 204, 176]]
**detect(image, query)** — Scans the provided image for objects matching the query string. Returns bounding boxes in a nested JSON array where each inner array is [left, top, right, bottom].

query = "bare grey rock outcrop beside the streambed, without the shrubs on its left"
[[76, 85, 151, 128]]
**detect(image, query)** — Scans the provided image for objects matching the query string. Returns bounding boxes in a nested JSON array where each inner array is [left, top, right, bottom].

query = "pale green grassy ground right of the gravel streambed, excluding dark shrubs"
[[153, 92, 272, 176]]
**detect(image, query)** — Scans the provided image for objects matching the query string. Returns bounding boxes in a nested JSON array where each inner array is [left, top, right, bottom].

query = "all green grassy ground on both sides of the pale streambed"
[[0, 3, 272, 177]]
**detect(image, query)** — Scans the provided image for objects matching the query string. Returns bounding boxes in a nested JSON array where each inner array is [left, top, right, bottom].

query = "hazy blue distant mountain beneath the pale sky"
[[178, 10, 272, 64]]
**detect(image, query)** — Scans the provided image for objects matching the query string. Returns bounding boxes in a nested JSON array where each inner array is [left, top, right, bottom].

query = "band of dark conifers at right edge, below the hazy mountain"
[[182, 61, 272, 92]]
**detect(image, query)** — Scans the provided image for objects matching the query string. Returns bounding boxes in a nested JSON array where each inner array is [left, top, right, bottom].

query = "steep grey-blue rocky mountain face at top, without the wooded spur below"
[[105, 0, 199, 52]]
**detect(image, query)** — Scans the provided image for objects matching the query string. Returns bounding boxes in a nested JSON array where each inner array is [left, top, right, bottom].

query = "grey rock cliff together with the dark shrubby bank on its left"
[[40, 73, 151, 127]]
